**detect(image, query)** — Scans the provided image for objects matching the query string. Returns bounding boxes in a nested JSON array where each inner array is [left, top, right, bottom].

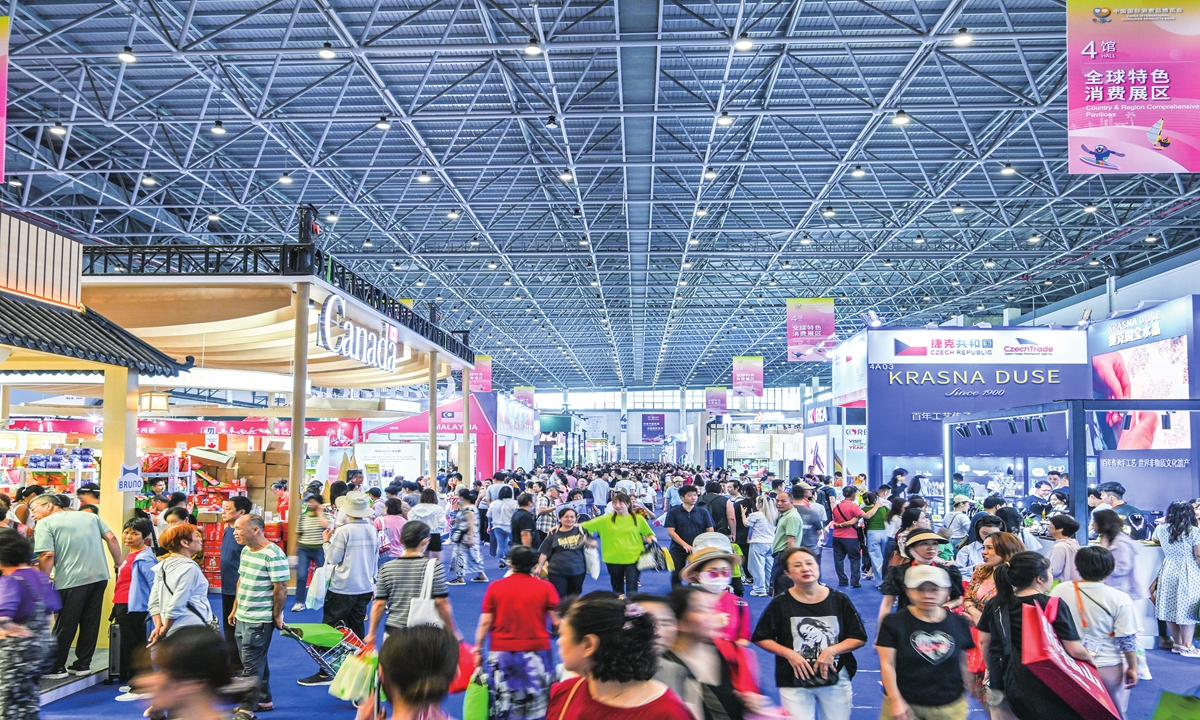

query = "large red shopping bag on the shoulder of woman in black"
[[1021, 598, 1121, 720]]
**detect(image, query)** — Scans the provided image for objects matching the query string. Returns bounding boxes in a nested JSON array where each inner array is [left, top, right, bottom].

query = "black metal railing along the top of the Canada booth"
[[83, 244, 475, 362]]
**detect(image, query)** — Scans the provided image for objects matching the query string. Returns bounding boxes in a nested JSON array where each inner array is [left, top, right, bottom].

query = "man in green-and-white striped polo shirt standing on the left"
[[229, 515, 289, 720]]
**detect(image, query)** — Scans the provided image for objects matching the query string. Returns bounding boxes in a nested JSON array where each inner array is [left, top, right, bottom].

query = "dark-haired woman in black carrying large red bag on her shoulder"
[[978, 551, 1096, 720]]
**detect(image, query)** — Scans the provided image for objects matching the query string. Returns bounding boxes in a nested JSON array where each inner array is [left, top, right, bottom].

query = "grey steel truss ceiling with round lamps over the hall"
[[0, 0, 1200, 388]]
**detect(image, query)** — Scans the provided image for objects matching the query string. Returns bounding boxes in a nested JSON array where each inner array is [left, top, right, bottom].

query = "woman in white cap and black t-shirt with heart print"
[[875, 565, 974, 720]]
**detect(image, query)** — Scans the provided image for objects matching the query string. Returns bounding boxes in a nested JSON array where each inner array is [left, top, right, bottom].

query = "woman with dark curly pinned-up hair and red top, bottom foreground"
[[546, 593, 692, 720]]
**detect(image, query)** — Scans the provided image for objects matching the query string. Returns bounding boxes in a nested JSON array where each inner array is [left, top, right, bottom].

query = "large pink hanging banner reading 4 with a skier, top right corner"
[[1067, 0, 1200, 174]]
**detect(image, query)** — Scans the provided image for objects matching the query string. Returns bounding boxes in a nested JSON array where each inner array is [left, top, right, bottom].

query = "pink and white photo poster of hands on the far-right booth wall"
[[1092, 335, 1192, 450]]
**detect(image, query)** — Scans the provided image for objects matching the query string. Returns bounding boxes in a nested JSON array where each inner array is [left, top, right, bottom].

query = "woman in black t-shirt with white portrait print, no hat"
[[751, 547, 866, 720]]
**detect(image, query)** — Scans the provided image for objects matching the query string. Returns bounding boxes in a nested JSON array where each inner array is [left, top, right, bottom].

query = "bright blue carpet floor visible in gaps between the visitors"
[[42, 542, 1200, 720]]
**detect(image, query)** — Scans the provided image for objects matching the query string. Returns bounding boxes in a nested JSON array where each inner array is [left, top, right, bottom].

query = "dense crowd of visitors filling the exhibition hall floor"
[[7, 463, 1200, 720]]
